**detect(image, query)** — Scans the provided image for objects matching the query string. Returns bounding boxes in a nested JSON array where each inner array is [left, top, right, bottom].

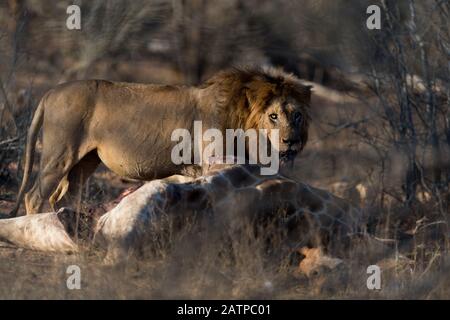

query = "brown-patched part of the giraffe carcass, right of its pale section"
[[166, 165, 361, 252]]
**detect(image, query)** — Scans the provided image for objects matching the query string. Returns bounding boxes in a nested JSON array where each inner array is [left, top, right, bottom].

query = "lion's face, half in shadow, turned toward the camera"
[[259, 97, 308, 162]]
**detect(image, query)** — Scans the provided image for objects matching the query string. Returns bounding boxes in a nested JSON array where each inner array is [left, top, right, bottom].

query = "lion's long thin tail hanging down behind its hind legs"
[[9, 97, 45, 217]]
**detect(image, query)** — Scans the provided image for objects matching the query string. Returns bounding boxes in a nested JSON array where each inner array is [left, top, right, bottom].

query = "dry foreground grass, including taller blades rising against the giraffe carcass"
[[0, 206, 450, 299]]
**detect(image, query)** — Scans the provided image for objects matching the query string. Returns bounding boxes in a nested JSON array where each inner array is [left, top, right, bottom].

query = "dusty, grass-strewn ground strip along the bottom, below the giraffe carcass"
[[0, 232, 450, 299]]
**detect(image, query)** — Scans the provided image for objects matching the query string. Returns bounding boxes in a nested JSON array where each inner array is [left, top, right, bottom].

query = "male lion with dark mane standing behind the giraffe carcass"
[[11, 69, 311, 216]]
